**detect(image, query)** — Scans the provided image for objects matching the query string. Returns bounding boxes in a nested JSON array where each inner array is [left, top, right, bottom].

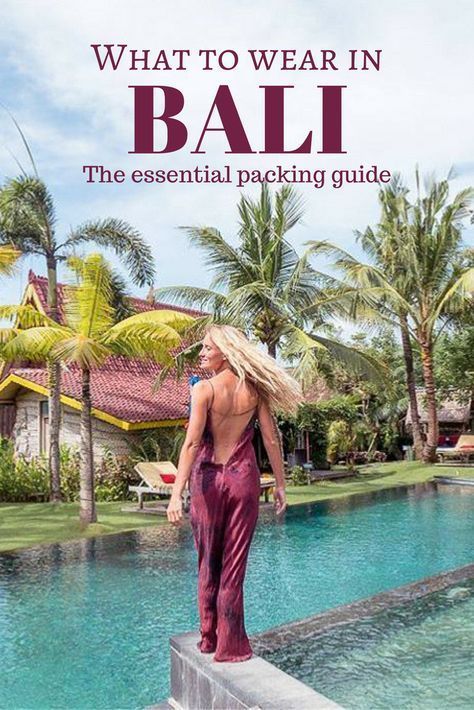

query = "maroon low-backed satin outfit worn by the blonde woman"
[[190, 383, 260, 661]]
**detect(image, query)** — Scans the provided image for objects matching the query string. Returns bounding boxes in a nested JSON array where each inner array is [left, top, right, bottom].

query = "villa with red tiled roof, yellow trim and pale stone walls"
[[0, 271, 201, 460]]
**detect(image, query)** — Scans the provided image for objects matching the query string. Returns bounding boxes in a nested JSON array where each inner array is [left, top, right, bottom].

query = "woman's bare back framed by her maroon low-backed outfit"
[[207, 371, 258, 464]]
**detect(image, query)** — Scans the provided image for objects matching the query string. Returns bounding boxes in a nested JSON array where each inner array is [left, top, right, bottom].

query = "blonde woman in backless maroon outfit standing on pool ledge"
[[167, 325, 301, 661]]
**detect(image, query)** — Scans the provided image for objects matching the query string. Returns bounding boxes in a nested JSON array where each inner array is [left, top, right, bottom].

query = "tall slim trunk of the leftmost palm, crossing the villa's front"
[[47, 257, 62, 503]]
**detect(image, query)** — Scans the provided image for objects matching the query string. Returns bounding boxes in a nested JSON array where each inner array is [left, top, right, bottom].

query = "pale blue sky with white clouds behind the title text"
[[0, 0, 474, 312]]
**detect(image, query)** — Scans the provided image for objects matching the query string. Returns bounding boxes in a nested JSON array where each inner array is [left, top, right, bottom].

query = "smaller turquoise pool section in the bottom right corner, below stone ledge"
[[265, 579, 474, 710]]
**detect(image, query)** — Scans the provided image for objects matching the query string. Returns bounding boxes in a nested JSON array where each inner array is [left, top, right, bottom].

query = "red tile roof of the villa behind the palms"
[[5, 271, 204, 423]]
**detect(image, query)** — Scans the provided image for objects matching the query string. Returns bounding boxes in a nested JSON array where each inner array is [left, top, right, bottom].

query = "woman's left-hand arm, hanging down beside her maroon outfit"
[[167, 380, 211, 522]]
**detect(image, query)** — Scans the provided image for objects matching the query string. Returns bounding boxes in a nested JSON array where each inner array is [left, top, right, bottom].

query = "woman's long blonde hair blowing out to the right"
[[206, 325, 303, 414]]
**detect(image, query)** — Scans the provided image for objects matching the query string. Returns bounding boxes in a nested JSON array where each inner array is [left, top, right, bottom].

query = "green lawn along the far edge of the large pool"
[[0, 462, 474, 551]]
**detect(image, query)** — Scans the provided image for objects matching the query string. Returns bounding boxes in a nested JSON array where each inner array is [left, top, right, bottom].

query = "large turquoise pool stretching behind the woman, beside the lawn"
[[0, 485, 474, 710]]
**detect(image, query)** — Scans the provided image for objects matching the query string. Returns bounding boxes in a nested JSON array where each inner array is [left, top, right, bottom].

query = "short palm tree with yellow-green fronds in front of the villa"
[[0, 254, 193, 524]]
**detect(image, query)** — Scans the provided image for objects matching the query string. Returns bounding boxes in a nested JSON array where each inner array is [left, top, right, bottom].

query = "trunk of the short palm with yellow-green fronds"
[[79, 368, 97, 525]]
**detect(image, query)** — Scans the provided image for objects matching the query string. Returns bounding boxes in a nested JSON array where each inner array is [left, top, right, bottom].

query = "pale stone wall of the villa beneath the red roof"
[[12, 392, 139, 461]]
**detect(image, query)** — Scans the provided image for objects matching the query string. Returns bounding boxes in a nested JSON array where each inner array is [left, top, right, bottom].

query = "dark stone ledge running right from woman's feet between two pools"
[[251, 564, 474, 654]]
